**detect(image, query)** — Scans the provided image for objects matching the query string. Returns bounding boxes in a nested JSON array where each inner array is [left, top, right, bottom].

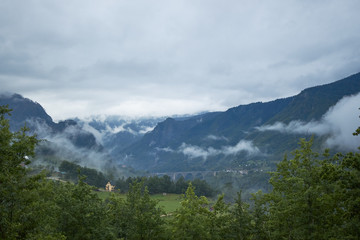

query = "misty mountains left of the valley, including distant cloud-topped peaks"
[[0, 93, 163, 176]]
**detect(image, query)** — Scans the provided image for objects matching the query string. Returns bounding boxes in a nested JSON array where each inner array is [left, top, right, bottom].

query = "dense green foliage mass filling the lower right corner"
[[262, 139, 360, 239]]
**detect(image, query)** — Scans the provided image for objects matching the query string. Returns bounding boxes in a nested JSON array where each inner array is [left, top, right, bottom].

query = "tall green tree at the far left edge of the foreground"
[[0, 106, 63, 239]]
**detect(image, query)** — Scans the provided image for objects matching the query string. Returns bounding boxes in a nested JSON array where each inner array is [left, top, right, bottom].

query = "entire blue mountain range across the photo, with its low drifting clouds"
[[0, 73, 360, 172]]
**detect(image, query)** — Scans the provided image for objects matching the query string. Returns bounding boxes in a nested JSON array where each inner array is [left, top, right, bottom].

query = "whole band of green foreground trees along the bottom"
[[0, 107, 360, 240]]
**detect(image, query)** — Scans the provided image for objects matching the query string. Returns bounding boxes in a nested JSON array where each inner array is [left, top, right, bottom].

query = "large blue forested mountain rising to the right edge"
[[122, 73, 360, 172]]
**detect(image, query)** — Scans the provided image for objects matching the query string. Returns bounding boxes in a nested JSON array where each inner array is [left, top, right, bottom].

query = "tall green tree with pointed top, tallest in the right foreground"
[[266, 139, 326, 239]]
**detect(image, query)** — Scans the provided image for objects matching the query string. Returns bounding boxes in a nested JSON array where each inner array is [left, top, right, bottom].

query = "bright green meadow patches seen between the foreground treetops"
[[96, 192, 181, 213]]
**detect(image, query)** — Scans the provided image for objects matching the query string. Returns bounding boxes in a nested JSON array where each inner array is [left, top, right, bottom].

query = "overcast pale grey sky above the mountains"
[[0, 0, 360, 121]]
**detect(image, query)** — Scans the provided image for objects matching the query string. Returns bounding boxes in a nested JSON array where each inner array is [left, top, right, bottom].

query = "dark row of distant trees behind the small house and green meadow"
[[59, 161, 215, 197]]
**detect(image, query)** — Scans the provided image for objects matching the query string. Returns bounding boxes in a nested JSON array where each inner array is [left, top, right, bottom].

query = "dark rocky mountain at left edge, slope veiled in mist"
[[0, 94, 114, 174]]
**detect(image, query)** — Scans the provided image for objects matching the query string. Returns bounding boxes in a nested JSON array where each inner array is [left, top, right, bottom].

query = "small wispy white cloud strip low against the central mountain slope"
[[177, 140, 260, 159]]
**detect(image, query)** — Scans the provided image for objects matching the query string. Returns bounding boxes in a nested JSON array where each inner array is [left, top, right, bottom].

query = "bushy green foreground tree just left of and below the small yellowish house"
[[54, 177, 112, 240]]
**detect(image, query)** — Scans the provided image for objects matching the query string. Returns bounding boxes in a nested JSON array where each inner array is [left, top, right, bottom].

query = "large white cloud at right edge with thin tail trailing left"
[[257, 94, 360, 150]]
